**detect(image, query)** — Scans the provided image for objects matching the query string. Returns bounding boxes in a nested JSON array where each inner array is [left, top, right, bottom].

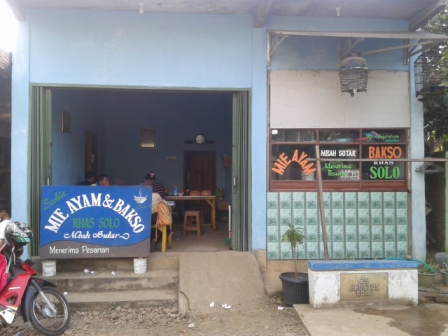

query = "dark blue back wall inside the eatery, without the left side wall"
[[104, 92, 232, 190]]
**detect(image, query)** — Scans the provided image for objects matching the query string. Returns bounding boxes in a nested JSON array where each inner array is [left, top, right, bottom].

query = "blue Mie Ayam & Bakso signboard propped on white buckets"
[[40, 186, 152, 259]]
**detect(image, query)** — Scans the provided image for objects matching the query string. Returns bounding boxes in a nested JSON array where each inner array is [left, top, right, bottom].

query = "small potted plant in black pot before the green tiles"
[[280, 224, 309, 306]]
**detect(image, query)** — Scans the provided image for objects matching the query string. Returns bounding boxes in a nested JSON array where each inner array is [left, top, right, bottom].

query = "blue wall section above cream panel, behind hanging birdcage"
[[267, 17, 409, 71]]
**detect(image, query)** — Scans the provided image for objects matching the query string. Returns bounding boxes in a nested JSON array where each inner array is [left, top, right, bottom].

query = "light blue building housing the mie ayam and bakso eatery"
[[7, 0, 446, 261]]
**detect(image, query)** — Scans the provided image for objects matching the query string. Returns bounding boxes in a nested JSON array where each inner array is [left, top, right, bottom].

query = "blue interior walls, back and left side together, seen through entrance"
[[52, 89, 232, 201]]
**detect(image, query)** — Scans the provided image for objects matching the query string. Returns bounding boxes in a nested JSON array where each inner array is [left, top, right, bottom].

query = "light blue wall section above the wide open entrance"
[[29, 10, 256, 88]]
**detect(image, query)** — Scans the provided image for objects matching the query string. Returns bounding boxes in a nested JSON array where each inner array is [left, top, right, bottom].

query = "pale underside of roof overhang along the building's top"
[[6, 0, 446, 31]]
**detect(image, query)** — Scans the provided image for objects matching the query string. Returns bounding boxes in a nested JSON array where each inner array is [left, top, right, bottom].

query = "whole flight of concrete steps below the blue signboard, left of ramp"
[[32, 252, 179, 311]]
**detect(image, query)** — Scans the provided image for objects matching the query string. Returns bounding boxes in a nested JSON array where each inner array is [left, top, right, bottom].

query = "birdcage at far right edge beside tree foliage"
[[414, 53, 444, 97]]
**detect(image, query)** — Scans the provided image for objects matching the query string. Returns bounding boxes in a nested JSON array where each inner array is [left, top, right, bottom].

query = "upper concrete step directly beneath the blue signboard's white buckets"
[[39, 269, 179, 292]]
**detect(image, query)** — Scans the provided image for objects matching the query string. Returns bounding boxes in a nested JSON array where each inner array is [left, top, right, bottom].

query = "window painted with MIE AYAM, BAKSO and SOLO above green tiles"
[[270, 129, 407, 181]]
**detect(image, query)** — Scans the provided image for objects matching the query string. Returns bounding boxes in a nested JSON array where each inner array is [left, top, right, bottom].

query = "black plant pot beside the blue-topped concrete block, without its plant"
[[280, 272, 310, 306]]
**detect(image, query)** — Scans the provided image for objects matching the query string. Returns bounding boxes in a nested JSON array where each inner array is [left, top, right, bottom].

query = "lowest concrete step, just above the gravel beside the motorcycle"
[[66, 289, 178, 311]]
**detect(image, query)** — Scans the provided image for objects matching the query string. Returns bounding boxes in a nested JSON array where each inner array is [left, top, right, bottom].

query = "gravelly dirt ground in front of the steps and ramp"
[[6, 297, 309, 336]]
